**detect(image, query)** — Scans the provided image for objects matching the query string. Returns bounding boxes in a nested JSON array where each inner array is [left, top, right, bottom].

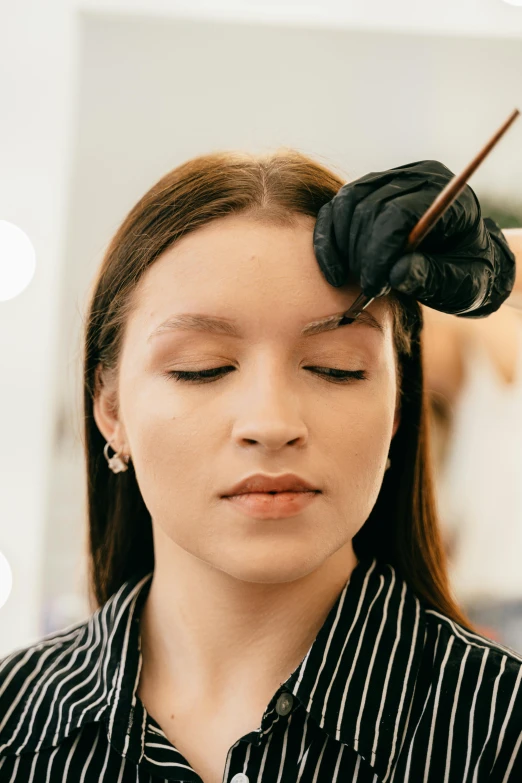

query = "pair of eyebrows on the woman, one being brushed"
[[147, 308, 384, 342]]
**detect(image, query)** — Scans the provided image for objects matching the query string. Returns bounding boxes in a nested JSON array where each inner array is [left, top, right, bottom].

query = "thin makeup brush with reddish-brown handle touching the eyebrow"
[[310, 109, 520, 329]]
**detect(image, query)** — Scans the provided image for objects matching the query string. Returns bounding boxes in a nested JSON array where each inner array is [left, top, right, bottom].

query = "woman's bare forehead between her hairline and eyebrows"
[[129, 215, 388, 344]]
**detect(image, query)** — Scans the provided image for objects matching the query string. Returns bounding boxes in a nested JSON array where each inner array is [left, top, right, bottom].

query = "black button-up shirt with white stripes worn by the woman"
[[0, 560, 522, 783]]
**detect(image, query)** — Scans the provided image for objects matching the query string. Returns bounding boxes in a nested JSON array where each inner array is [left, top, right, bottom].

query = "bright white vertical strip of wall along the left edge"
[[0, 0, 75, 654]]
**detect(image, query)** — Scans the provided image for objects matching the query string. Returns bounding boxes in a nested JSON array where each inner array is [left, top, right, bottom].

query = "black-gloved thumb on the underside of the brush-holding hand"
[[389, 252, 493, 315]]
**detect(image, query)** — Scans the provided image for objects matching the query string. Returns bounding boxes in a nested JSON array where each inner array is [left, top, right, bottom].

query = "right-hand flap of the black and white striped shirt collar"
[[287, 560, 424, 779]]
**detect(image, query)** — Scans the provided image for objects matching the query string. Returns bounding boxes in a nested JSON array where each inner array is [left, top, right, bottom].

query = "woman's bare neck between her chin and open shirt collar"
[[140, 529, 357, 703]]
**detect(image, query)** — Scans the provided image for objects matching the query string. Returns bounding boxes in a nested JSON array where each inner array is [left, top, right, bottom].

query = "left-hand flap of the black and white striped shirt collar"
[[0, 572, 152, 756]]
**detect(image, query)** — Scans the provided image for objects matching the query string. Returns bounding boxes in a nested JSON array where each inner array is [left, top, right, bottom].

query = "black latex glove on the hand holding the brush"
[[314, 160, 515, 318]]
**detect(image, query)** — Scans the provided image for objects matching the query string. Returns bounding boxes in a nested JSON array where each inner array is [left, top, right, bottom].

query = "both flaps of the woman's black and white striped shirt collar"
[[0, 560, 424, 777]]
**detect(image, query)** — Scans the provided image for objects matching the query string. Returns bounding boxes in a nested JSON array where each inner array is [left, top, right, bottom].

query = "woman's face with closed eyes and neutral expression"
[[95, 216, 399, 583]]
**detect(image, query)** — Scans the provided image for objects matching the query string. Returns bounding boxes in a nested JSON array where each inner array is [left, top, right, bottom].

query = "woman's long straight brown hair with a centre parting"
[[84, 148, 469, 626]]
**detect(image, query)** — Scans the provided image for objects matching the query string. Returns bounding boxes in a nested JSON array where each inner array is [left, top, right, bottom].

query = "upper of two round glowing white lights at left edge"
[[0, 220, 36, 302]]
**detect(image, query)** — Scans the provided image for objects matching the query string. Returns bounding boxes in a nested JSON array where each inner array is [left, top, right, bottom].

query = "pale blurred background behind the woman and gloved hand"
[[0, 0, 522, 656]]
